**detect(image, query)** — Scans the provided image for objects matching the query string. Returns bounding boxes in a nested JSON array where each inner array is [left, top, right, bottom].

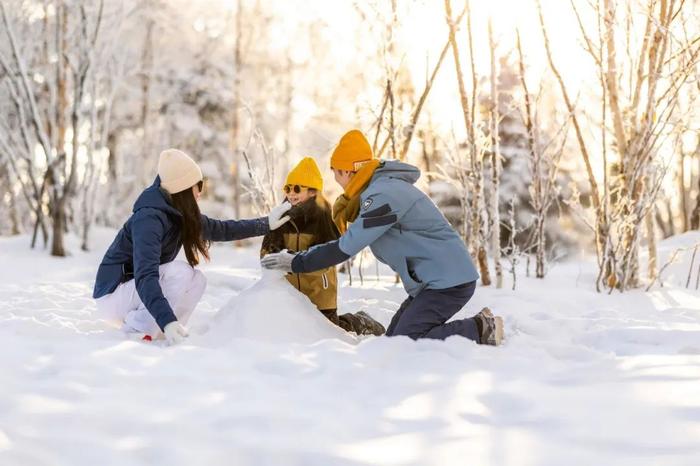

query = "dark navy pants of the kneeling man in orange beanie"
[[386, 282, 479, 342]]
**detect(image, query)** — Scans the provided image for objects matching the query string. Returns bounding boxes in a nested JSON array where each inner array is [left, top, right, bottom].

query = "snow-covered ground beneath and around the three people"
[[0, 230, 700, 466]]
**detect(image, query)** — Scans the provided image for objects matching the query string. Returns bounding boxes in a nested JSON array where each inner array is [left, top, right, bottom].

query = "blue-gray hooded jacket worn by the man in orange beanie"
[[292, 160, 479, 296]]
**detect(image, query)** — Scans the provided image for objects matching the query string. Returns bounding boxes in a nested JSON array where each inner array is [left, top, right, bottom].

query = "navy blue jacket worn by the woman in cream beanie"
[[92, 178, 269, 330]]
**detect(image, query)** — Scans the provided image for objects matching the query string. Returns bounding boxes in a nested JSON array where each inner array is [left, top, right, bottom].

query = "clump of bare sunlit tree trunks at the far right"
[[538, 0, 700, 291]]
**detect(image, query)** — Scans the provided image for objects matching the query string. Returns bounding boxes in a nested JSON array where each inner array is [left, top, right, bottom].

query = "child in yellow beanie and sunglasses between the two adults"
[[260, 157, 384, 334]]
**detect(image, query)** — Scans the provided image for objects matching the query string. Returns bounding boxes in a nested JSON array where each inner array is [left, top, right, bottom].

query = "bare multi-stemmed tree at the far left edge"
[[0, 1, 112, 256]]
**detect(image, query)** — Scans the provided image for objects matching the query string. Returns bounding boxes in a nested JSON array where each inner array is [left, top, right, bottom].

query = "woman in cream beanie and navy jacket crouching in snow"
[[93, 149, 290, 344]]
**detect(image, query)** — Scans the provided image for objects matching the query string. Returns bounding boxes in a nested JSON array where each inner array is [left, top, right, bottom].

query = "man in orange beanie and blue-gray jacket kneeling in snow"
[[262, 130, 503, 345]]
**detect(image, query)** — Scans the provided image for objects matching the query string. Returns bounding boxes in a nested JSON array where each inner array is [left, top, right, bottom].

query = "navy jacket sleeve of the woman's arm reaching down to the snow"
[[131, 211, 177, 330]]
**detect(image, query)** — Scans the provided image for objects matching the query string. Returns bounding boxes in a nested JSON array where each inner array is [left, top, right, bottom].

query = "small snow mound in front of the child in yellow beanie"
[[201, 270, 357, 346]]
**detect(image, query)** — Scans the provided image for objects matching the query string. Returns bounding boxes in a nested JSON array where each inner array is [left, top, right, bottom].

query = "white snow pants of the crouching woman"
[[96, 261, 207, 337]]
